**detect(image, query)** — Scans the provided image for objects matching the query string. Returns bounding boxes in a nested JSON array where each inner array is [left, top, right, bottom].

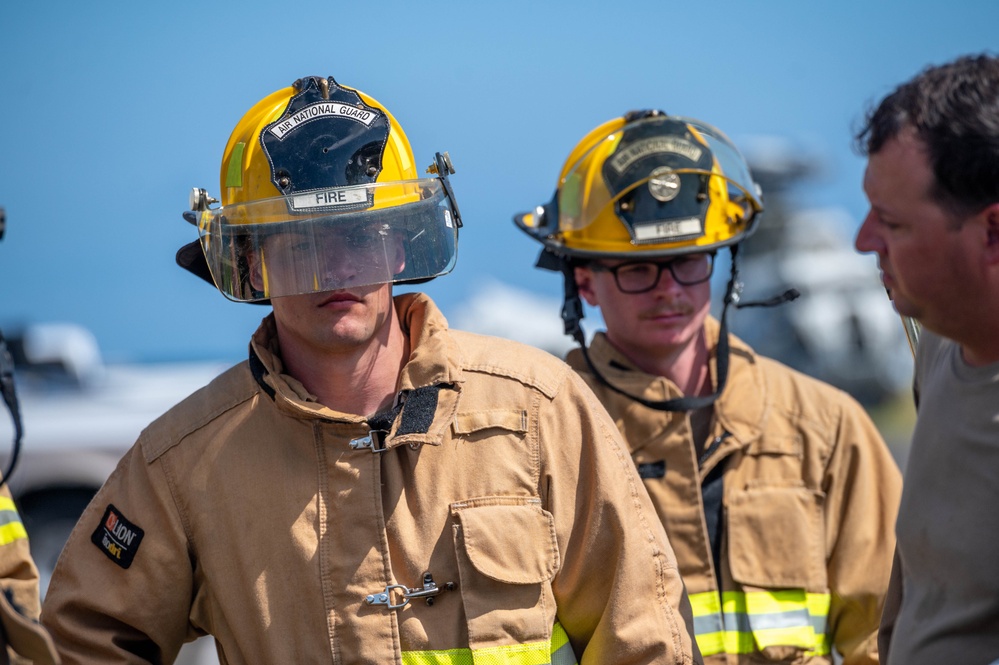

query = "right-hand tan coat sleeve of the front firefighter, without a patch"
[[538, 372, 701, 665]]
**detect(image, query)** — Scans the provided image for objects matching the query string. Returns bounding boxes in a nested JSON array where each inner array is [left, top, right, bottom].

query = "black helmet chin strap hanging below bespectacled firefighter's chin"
[[562, 244, 800, 411]]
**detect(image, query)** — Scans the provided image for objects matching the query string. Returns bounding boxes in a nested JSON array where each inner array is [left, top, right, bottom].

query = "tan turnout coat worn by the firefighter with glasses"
[[568, 318, 901, 665]]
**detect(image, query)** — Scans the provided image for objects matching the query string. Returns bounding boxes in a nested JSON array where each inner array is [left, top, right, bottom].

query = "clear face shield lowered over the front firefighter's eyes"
[[198, 178, 459, 302]]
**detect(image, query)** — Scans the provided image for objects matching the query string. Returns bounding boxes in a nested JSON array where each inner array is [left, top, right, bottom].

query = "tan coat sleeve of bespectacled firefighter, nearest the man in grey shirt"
[[824, 395, 902, 665]]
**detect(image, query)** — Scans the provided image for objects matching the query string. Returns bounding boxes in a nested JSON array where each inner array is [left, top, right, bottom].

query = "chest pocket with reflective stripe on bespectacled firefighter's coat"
[[723, 486, 829, 662]]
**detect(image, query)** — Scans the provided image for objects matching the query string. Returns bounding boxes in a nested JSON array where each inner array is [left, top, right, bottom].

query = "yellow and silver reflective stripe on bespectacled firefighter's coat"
[[690, 589, 830, 656]]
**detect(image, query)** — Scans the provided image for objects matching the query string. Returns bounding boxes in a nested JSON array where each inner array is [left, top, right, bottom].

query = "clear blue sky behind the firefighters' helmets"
[[0, 0, 999, 360]]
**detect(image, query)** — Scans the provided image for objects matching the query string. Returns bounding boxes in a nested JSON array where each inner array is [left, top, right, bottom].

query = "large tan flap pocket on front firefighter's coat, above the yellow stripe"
[[451, 497, 561, 650]]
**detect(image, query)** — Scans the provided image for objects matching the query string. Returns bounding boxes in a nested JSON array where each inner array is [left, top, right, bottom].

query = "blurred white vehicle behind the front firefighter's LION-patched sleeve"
[[0, 324, 230, 665]]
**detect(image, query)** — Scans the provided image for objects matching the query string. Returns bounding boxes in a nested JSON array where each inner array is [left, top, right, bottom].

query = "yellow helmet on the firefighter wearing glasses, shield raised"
[[515, 111, 763, 258]]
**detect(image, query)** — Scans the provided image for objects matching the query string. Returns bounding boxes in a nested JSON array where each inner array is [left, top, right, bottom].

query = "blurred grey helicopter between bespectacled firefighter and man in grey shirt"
[[726, 137, 912, 406]]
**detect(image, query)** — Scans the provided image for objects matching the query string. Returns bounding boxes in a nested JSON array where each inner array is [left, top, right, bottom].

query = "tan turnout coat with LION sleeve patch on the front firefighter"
[[42, 295, 692, 665]]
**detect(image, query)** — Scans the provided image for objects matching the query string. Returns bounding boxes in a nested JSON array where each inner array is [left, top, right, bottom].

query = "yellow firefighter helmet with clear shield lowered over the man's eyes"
[[177, 77, 461, 302]]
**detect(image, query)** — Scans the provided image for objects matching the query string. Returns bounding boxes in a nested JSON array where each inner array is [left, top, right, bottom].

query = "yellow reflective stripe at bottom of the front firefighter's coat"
[[402, 623, 577, 665]]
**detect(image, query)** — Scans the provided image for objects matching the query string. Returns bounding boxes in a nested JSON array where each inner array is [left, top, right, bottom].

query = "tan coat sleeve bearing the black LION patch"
[[42, 444, 194, 665]]
